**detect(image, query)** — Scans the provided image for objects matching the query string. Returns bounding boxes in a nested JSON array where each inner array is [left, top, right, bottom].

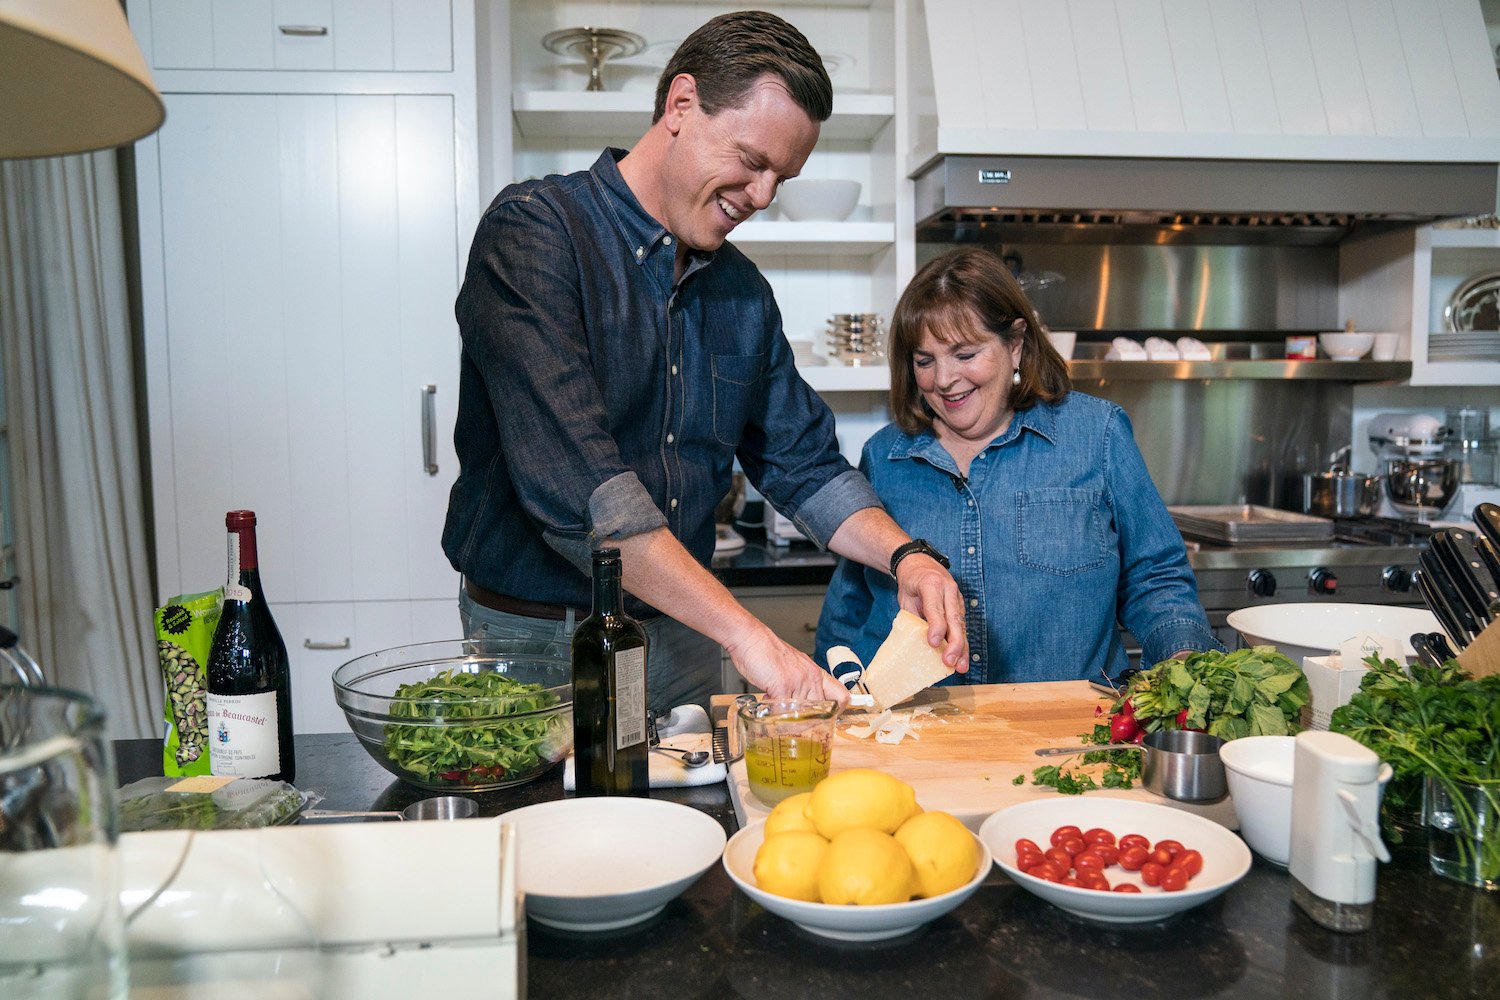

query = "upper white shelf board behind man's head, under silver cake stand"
[[510, 90, 896, 141]]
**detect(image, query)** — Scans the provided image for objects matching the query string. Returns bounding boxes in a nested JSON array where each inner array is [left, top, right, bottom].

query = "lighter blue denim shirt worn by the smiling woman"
[[818, 393, 1223, 684]]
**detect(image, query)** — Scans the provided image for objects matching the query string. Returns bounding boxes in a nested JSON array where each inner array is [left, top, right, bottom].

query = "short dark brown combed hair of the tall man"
[[651, 10, 834, 123]]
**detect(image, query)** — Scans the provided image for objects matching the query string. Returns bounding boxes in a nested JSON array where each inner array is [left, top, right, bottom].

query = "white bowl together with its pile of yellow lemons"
[[723, 769, 995, 942]]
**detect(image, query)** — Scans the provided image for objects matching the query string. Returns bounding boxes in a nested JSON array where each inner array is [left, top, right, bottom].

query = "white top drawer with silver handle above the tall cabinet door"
[[150, 0, 453, 72]]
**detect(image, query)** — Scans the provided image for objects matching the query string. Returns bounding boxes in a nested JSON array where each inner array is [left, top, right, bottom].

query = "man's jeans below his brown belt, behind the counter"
[[459, 586, 722, 718]]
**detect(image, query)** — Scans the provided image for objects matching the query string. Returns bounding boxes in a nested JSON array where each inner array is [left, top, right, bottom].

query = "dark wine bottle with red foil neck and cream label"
[[209, 510, 297, 783]]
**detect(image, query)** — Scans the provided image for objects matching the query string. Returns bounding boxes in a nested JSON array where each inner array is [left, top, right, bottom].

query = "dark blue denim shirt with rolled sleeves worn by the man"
[[443, 150, 879, 615]]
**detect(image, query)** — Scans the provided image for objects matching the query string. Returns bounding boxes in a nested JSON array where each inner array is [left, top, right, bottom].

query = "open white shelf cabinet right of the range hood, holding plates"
[[1338, 226, 1500, 385]]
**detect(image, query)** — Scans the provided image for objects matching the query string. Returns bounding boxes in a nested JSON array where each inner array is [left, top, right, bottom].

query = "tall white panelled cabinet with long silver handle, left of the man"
[[132, 0, 479, 732]]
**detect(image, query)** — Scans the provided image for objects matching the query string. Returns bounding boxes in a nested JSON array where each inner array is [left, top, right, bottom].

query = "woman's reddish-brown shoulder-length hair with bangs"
[[890, 247, 1073, 433]]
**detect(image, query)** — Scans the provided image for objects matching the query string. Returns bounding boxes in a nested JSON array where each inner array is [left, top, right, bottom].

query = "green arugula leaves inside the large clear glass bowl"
[[384, 670, 570, 786]]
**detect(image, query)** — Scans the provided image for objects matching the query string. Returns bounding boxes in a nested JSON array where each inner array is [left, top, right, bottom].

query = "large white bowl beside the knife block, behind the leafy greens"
[[1227, 604, 1443, 667]]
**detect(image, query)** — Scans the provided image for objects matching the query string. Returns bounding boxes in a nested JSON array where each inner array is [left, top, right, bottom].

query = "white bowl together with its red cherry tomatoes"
[[980, 796, 1250, 924]]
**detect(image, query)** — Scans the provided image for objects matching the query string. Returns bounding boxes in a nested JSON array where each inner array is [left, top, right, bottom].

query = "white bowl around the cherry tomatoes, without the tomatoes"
[[980, 796, 1250, 924]]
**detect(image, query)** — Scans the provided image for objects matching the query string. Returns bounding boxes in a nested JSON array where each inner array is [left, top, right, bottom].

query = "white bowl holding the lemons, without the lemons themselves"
[[725, 820, 992, 942]]
